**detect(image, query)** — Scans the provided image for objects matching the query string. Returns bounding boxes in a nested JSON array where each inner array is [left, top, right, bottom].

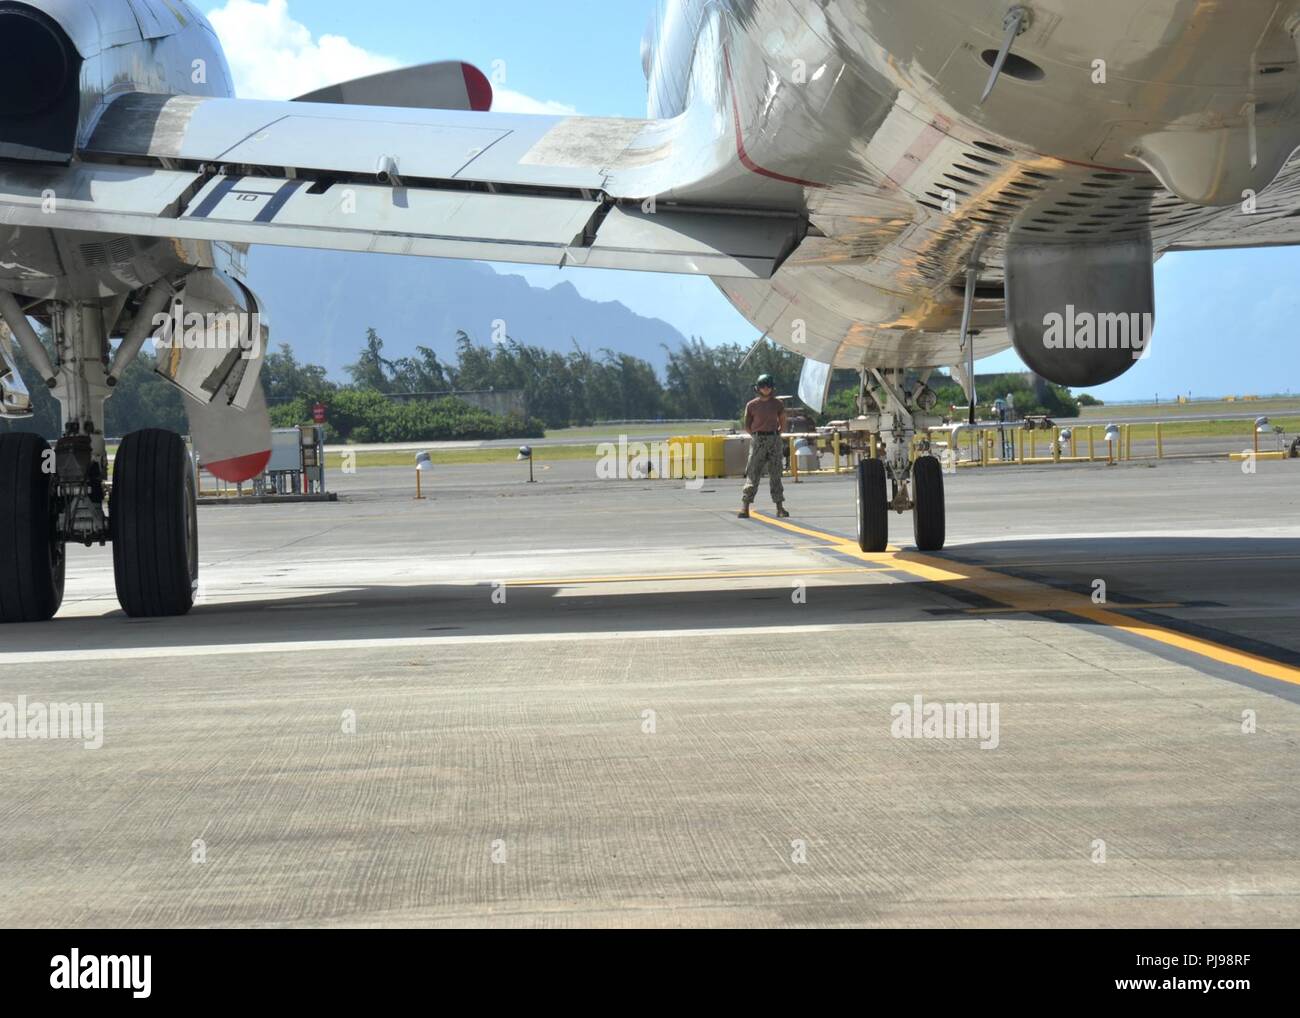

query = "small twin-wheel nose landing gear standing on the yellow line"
[[850, 369, 945, 551]]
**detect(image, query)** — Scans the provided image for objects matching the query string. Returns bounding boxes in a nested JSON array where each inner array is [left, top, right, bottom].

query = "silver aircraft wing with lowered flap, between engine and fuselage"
[[0, 94, 806, 280]]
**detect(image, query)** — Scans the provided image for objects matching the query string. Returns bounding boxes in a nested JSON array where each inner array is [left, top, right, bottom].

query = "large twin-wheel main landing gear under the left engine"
[[0, 300, 199, 623]]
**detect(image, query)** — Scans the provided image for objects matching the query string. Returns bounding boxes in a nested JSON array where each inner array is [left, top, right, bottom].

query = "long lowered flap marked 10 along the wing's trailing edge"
[[0, 163, 802, 278]]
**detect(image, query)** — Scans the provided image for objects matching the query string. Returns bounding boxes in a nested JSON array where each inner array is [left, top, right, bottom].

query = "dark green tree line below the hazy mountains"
[[4, 328, 1079, 442]]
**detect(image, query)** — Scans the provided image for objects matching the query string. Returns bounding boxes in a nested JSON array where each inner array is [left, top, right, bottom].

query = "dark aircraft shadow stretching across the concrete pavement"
[[17, 537, 1300, 664]]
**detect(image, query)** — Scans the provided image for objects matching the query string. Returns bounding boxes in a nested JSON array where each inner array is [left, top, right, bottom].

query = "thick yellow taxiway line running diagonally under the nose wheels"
[[751, 511, 1300, 685]]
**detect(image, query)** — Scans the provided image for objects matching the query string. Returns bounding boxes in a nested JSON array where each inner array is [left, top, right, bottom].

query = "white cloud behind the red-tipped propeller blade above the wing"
[[208, 0, 577, 116]]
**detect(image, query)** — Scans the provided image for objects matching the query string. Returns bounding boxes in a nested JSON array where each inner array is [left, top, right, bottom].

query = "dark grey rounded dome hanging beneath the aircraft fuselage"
[[1006, 237, 1156, 387]]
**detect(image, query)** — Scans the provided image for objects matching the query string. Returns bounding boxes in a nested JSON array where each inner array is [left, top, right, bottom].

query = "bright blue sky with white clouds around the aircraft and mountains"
[[200, 0, 1300, 400]]
